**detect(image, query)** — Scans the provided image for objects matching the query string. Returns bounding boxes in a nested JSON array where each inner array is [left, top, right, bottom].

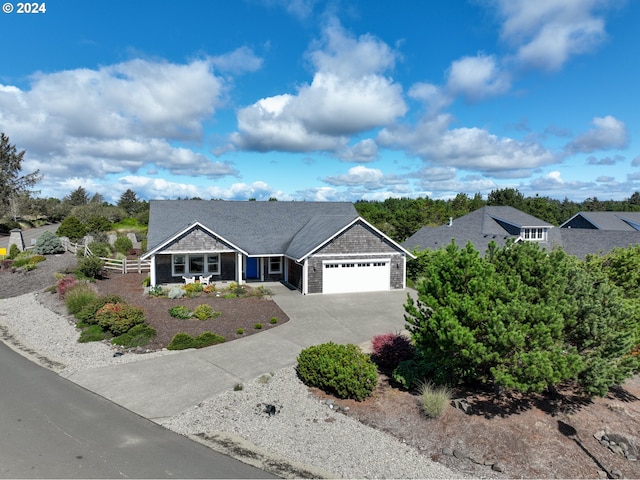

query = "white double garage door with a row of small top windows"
[[322, 258, 391, 293]]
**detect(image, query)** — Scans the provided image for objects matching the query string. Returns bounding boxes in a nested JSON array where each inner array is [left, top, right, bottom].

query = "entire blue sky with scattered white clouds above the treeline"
[[0, 0, 640, 201]]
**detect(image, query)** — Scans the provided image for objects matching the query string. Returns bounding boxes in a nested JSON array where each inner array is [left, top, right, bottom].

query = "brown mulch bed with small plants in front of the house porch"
[[95, 273, 289, 350]]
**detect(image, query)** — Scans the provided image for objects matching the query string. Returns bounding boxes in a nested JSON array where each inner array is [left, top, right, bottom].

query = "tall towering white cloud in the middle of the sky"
[[231, 22, 407, 152]]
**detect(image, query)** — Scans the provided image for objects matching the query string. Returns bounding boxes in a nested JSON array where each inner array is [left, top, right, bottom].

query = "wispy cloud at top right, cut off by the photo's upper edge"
[[497, 0, 614, 70]]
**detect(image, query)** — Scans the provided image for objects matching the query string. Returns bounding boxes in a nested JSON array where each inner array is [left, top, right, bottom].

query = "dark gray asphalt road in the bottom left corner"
[[0, 342, 274, 478]]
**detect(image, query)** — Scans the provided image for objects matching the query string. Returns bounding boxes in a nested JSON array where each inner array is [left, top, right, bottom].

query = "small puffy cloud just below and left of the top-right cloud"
[[447, 54, 510, 101]]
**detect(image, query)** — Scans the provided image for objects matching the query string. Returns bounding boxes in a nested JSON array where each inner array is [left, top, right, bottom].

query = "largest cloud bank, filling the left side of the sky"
[[0, 58, 238, 195]]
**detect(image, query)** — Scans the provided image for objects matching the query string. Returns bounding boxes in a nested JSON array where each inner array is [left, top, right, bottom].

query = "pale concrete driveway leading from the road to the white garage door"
[[67, 283, 408, 422]]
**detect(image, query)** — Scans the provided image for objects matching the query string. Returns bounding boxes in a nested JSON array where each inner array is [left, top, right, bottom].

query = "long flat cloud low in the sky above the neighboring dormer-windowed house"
[[377, 114, 556, 174]]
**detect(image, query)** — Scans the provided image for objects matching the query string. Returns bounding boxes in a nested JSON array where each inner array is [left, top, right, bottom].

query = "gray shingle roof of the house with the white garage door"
[[147, 200, 358, 258]]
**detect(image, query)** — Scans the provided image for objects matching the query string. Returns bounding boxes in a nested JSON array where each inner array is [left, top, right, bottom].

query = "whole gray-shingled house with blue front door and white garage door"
[[142, 200, 412, 294]]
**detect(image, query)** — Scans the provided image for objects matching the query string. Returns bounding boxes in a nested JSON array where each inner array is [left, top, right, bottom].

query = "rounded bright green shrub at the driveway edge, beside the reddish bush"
[[297, 342, 378, 401]]
